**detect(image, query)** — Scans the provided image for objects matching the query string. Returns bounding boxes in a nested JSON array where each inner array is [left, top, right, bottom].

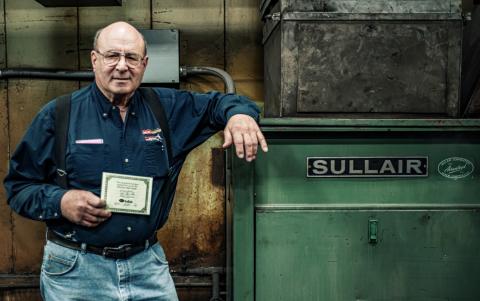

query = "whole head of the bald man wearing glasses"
[[91, 25, 148, 101]]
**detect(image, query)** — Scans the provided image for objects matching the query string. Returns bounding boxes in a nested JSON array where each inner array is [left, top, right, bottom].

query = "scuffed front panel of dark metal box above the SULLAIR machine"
[[292, 22, 459, 113]]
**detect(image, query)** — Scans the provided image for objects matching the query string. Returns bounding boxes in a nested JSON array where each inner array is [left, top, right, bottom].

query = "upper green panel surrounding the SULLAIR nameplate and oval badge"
[[255, 132, 480, 205]]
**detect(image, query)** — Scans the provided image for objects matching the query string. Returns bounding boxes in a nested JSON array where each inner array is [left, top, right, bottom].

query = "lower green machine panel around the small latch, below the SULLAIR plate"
[[255, 210, 480, 301]]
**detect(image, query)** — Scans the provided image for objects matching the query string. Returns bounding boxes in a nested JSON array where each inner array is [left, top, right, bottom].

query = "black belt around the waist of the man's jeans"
[[47, 229, 157, 259]]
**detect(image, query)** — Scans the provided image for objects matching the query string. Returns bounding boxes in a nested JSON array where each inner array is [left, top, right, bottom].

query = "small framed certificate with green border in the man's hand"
[[101, 172, 153, 215]]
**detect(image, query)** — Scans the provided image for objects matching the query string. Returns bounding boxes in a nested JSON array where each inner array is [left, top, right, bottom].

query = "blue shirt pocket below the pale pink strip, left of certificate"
[[67, 144, 108, 187]]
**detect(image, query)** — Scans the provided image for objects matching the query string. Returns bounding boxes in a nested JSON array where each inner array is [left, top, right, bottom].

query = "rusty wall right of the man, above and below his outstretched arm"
[[152, 0, 229, 267]]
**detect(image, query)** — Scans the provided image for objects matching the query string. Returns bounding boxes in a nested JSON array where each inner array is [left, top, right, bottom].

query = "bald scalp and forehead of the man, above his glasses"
[[93, 21, 147, 56]]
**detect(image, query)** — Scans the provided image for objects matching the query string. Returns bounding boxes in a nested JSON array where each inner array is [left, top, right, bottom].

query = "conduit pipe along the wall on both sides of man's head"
[[0, 66, 235, 93]]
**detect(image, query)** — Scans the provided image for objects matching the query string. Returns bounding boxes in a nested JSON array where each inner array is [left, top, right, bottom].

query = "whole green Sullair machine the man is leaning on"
[[227, 118, 480, 301]]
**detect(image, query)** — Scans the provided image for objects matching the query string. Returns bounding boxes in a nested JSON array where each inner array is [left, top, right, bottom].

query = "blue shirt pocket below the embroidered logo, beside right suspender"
[[144, 141, 168, 177]]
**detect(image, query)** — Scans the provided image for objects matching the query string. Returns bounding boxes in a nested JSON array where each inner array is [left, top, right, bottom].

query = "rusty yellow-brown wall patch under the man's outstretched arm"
[[159, 135, 225, 267]]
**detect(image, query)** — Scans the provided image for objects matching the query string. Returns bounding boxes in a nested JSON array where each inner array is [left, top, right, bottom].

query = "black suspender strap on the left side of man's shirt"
[[55, 94, 72, 189]]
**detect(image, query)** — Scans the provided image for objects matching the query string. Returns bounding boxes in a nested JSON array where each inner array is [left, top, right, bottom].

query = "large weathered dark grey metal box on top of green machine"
[[261, 0, 462, 117]]
